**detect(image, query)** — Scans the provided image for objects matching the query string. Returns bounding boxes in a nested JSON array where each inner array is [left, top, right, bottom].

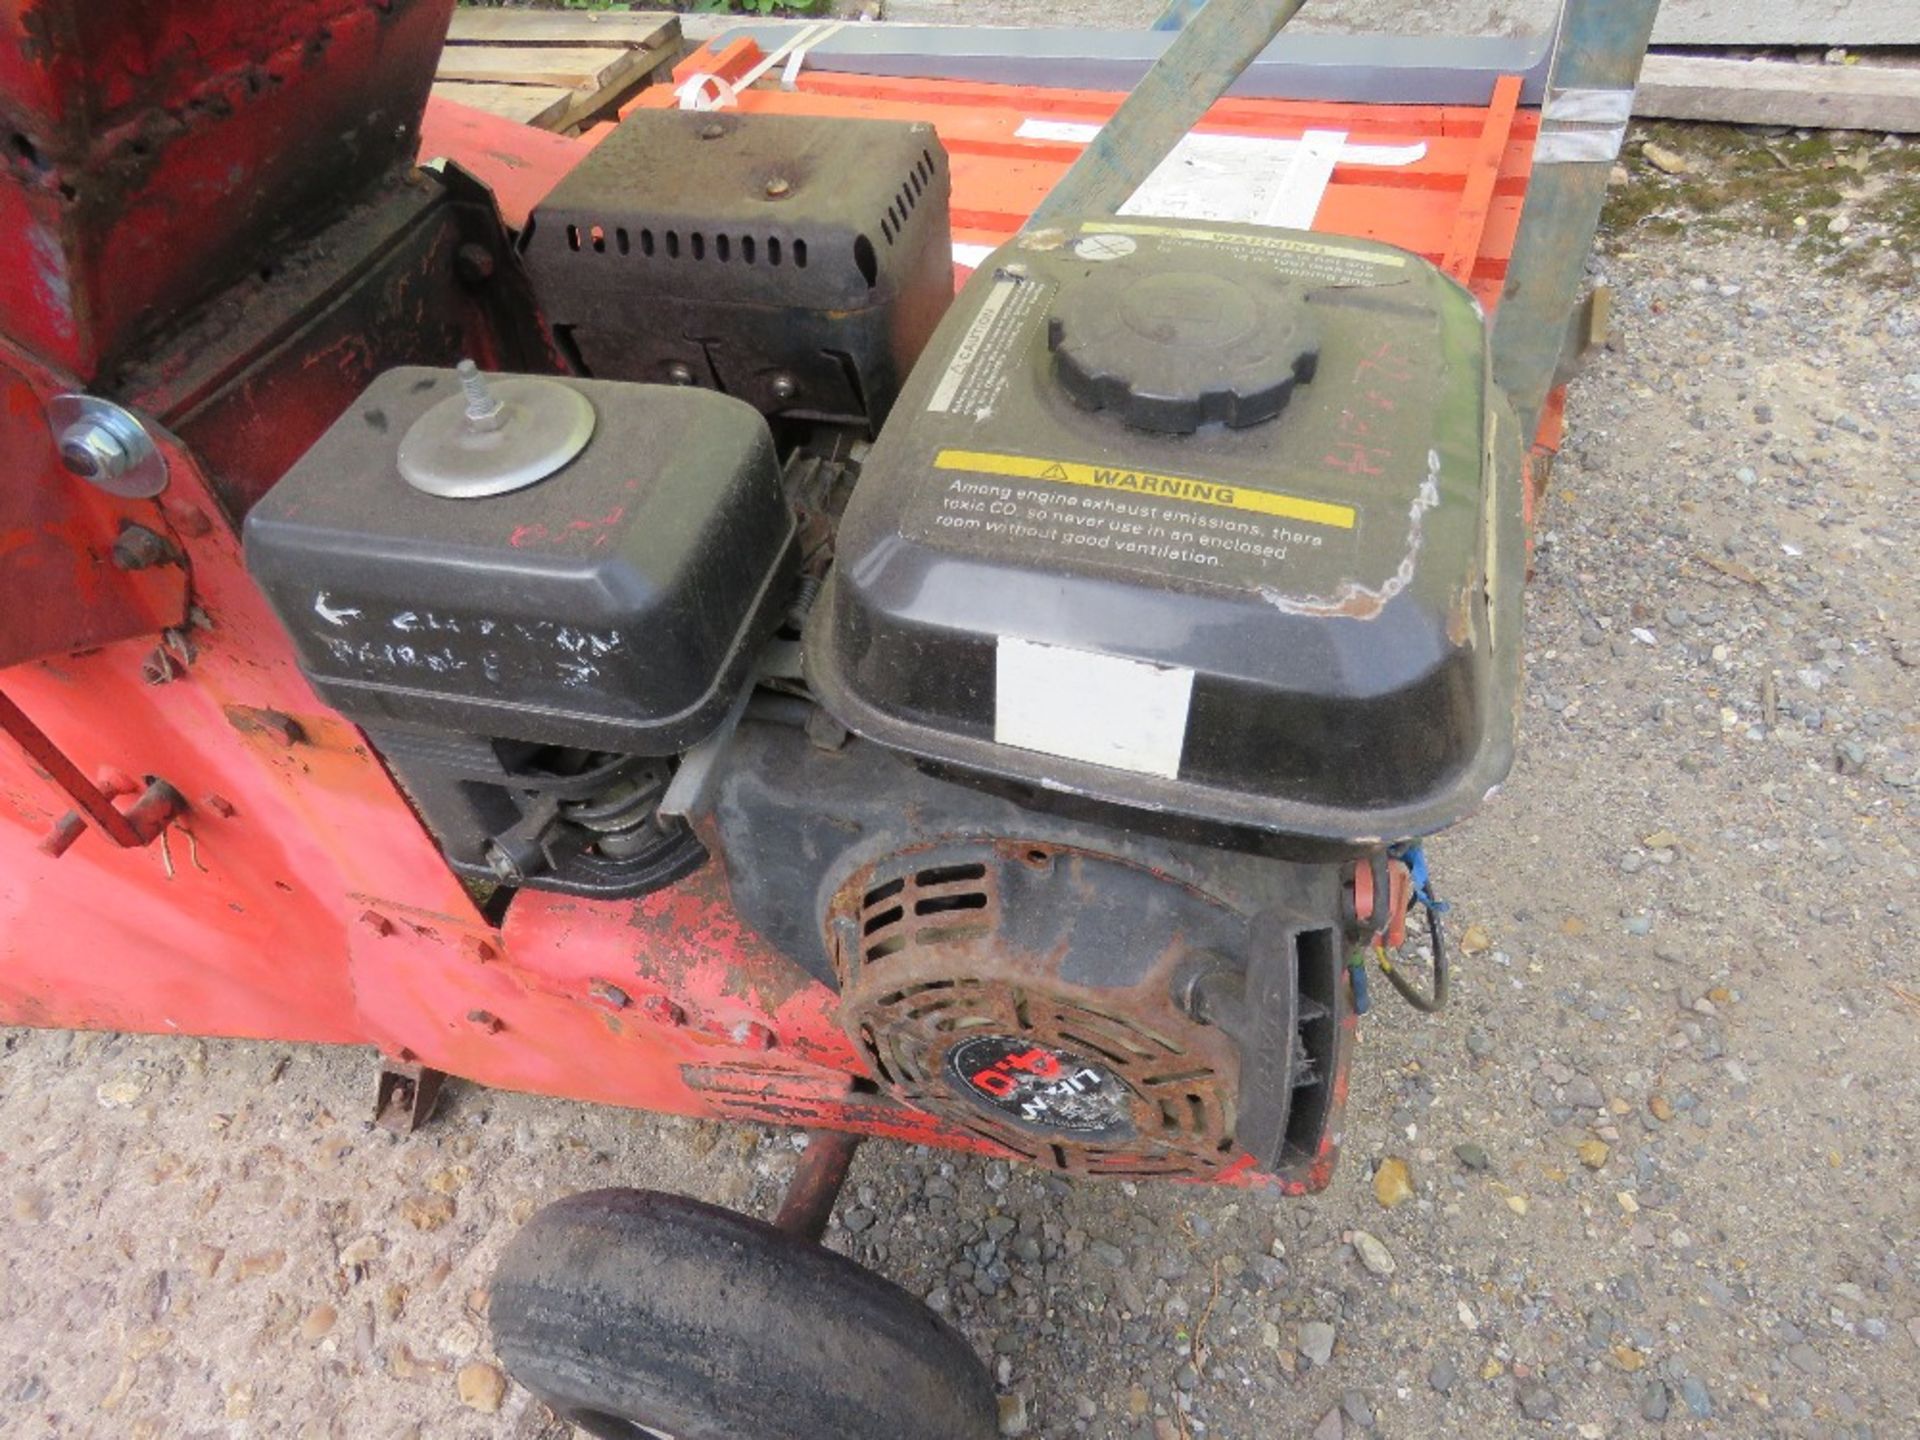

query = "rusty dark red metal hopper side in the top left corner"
[[0, 0, 453, 384]]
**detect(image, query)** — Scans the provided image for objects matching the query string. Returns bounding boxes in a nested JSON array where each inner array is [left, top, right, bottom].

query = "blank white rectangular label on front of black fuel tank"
[[993, 636, 1194, 780]]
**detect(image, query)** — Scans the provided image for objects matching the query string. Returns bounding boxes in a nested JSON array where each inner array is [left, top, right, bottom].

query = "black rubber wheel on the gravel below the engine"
[[490, 1190, 998, 1440]]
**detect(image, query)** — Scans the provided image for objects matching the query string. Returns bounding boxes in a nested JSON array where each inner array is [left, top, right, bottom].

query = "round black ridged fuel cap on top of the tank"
[[1046, 252, 1319, 434]]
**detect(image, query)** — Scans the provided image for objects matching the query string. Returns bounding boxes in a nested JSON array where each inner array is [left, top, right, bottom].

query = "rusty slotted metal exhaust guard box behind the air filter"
[[520, 109, 954, 432]]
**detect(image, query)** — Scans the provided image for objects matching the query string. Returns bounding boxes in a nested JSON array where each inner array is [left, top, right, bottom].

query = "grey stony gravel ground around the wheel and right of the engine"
[[0, 132, 1920, 1440]]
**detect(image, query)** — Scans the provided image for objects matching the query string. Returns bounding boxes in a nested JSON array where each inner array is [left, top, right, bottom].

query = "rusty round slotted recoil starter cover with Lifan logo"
[[833, 843, 1238, 1177]]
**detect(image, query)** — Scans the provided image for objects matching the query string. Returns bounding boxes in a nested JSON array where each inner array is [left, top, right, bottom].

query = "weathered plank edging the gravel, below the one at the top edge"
[[1634, 56, 1920, 132]]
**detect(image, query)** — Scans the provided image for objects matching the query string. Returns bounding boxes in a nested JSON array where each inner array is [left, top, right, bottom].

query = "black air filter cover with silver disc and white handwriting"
[[246, 367, 795, 755]]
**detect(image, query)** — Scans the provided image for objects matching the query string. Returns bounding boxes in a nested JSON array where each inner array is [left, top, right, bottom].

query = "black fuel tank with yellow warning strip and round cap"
[[806, 219, 1523, 845]]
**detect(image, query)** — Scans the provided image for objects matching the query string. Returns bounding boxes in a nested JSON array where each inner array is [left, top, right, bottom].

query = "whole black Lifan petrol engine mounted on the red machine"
[[248, 113, 1523, 1183]]
